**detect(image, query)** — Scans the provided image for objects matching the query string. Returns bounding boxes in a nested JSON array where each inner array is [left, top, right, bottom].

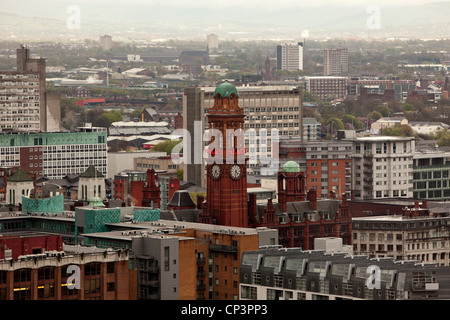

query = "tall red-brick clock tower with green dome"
[[206, 82, 248, 228]]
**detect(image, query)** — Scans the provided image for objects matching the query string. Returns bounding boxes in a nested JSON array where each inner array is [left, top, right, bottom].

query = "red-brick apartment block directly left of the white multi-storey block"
[[279, 138, 353, 199]]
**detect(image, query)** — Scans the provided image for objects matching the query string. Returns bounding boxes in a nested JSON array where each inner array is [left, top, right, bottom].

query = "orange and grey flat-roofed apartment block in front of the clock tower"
[[84, 219, 278, 300]]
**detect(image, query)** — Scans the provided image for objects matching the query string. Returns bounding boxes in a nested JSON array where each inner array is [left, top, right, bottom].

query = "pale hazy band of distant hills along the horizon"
[[0, 0, 450, 37]]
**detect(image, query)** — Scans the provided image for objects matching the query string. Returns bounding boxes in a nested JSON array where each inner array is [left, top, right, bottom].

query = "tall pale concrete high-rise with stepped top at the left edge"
[[0, 46, 61, 132]]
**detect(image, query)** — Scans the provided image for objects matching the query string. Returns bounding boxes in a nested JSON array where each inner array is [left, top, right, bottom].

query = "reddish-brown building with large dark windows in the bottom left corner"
[[0, 246, 136, 300]]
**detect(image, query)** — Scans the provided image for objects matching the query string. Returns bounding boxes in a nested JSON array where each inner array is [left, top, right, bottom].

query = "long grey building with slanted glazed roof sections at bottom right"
[[239, 244, 450, 300]]
